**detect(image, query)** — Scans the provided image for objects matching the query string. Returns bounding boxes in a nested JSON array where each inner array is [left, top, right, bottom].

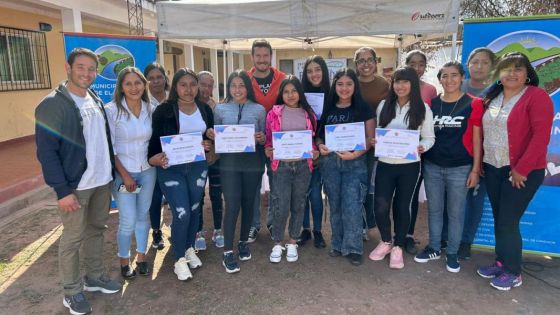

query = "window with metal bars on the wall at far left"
[[0, 26, 51, 92]]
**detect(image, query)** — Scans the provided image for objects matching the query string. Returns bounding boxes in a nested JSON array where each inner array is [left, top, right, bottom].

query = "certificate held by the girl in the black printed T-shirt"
[[325, 122, 366, 151]]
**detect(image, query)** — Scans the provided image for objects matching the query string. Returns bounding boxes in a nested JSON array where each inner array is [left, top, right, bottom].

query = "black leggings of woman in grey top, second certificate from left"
[[220, 169, 262, 251]]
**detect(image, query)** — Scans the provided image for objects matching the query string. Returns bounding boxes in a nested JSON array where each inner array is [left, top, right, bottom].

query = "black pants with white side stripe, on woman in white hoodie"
[[373, 161, 420, 247]]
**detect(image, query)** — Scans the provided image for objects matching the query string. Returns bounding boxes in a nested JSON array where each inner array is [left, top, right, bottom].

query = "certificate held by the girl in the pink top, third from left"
[[272, 130, 313, 160]]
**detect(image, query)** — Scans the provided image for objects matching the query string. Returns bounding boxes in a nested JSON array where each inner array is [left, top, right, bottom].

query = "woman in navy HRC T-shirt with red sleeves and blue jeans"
[[414, 61, 483, 272]]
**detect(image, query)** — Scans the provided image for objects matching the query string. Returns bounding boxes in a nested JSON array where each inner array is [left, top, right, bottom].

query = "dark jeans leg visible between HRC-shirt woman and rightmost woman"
[[461, 176, 486, 244]]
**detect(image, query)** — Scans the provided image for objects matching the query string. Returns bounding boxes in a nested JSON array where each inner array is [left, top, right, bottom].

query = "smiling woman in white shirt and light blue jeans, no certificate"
[[105, 67, 156, 279]]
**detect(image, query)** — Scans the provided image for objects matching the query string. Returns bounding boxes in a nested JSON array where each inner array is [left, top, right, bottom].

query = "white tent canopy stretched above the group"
[[157, 0, 459, 50]]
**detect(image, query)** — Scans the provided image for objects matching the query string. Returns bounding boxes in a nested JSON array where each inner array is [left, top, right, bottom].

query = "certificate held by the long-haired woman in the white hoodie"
[[375, 128, 420, 161]]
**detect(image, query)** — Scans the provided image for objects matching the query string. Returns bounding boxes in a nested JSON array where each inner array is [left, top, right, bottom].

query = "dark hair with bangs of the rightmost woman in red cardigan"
[[484, 51, 539, 109]]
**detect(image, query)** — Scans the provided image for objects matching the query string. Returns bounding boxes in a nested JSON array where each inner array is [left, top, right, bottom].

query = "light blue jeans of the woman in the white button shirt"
[[113, 167, 156, 258]]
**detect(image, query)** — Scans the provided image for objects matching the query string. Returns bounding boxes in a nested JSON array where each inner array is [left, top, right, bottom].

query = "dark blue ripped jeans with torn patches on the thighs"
[[157, 161, 208, 260]]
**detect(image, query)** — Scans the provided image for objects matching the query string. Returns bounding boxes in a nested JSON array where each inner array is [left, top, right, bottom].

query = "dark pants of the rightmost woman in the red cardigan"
[[484, 163, 544, 275]]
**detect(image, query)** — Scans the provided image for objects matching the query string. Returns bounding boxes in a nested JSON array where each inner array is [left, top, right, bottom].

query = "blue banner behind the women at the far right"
[[462, 16, 560, 256]]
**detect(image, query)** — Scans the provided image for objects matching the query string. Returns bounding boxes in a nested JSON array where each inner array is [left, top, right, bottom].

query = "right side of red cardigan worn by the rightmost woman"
[[500, 85, 554, 177]]
